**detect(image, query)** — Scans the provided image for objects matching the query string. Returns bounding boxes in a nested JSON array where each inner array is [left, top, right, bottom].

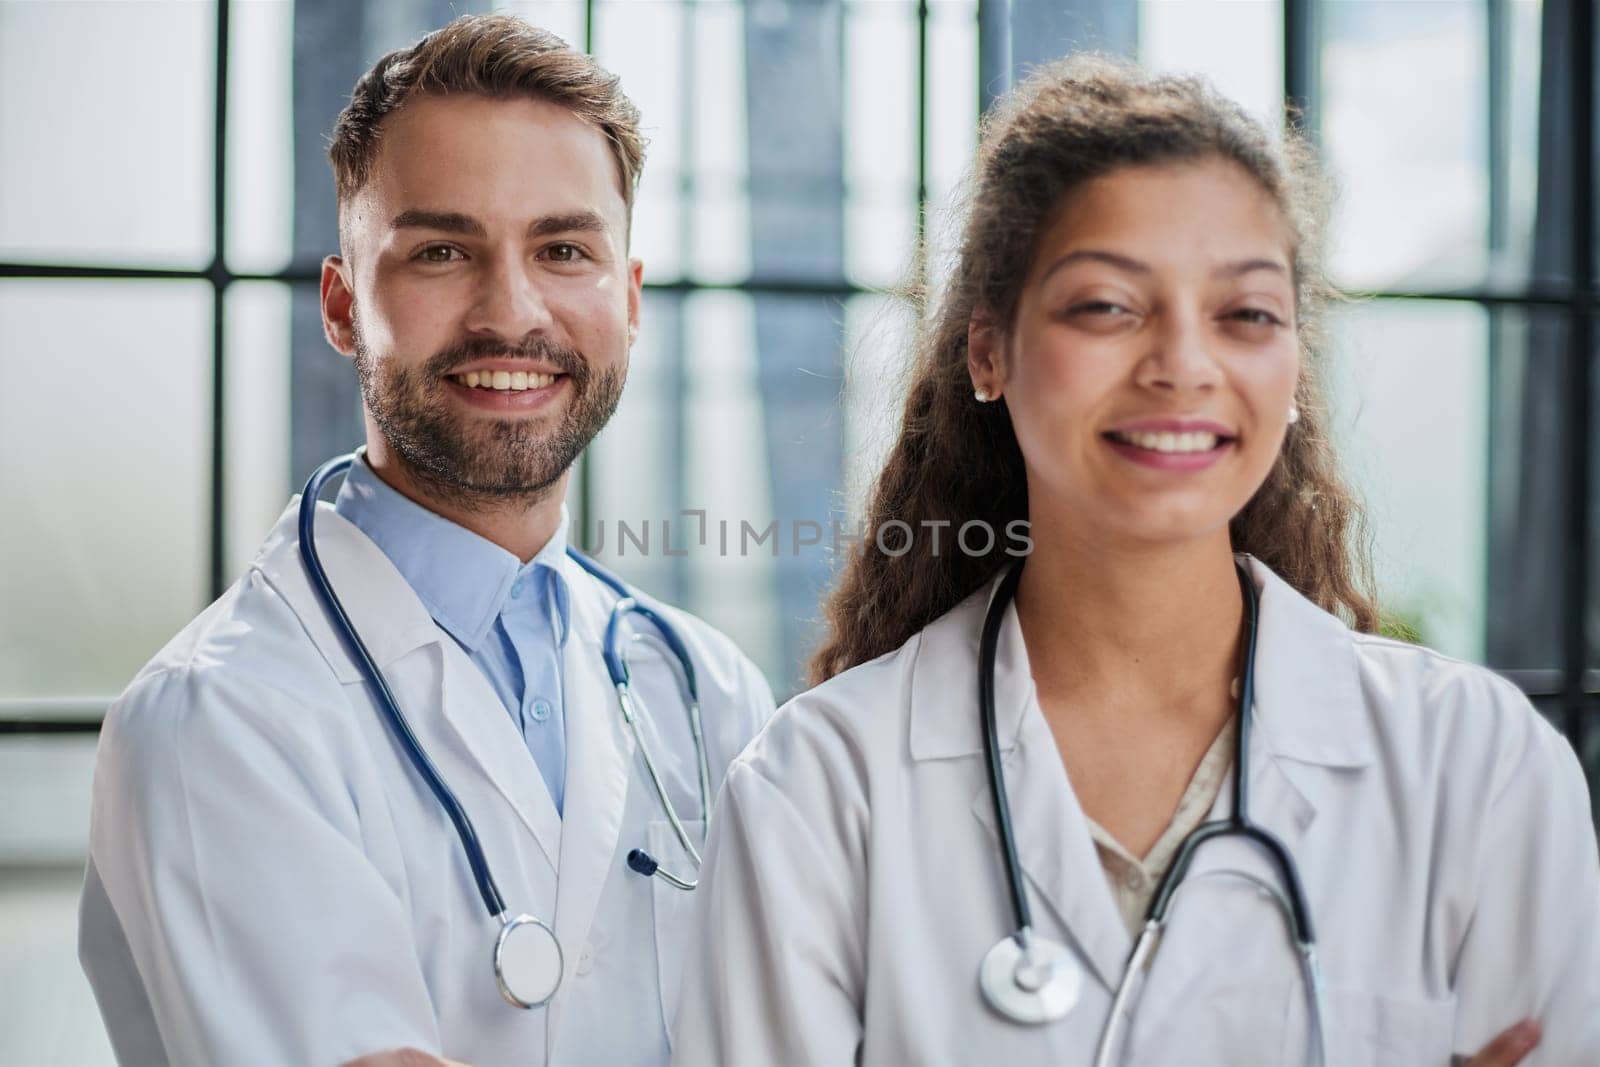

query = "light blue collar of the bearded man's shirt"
[[334, 454, 571, 653]]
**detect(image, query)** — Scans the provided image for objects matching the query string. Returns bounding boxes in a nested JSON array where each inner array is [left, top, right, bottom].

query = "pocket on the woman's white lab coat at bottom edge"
[[1323, 987, 1456, 1067]]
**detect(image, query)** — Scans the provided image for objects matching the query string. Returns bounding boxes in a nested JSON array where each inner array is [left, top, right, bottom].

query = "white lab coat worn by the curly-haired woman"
[[674, 563, 1600, 1067]]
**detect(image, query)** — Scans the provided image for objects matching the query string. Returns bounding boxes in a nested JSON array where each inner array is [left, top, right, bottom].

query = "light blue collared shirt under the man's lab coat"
[[334, 456, 571, 813]]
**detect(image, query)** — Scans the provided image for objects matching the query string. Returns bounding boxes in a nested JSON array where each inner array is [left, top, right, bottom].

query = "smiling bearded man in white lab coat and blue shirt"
[[80, 16, 773, 1065]]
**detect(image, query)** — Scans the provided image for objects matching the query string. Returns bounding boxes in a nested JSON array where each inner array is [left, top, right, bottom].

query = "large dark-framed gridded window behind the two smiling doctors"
[[0, 0, 1600, 1064]]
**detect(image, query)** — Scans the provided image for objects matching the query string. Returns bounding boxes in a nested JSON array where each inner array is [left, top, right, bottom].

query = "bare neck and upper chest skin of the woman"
[[1016, 511, 1243, 856]]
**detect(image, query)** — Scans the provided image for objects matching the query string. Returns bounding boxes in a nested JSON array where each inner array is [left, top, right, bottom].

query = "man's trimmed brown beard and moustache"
[[355, 323, 622, 510]]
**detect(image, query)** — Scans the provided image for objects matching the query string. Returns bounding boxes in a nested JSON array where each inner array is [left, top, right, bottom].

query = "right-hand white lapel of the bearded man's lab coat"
[[550, 576, 634, 1033]]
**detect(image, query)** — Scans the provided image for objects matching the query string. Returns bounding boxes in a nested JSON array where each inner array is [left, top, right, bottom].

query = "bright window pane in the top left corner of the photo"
[[0, 0, 216, 267]]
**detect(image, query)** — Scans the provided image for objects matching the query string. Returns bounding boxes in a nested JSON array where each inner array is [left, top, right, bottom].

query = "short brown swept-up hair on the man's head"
[[328, 14, 645, 223]]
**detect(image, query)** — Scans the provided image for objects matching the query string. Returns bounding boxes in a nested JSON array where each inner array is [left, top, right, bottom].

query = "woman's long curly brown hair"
[[810, 56, 1379, 683]]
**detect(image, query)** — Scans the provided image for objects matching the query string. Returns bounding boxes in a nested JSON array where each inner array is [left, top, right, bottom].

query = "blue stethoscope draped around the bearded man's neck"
[[299, 453, 710, 1008]]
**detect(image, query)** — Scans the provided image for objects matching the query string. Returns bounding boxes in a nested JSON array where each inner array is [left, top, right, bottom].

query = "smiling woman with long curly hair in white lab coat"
[[675, 61, 1600, 1064]]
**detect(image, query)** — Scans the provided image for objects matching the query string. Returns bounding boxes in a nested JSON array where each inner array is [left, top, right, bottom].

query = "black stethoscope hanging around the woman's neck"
[[978, 560, 1328, 1067]]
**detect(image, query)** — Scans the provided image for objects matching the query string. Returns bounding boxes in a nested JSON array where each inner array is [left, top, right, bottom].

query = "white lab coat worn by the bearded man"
[[80, 506, 771, 1067]]
